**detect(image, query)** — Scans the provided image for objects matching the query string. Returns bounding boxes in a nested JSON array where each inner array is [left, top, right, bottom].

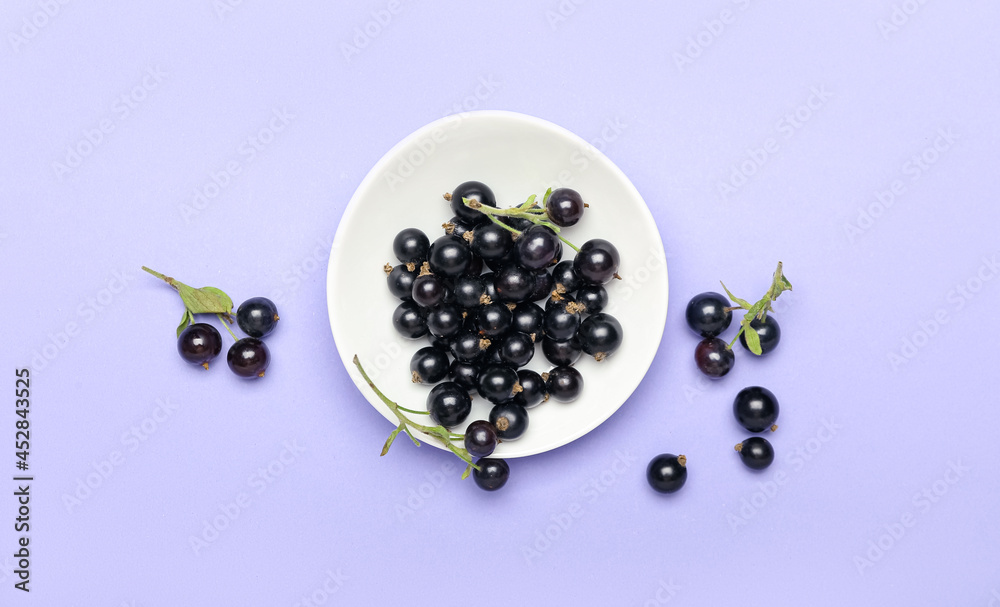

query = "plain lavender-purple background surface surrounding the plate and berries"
[[0, 0, 1000, 607]]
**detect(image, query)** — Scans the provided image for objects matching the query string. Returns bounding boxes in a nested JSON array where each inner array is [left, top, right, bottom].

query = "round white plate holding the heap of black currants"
[[327, 111, 667, 457]]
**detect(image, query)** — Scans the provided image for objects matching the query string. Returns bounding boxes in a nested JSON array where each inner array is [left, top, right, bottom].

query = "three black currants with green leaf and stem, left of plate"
[[142, 266, 278, 378]]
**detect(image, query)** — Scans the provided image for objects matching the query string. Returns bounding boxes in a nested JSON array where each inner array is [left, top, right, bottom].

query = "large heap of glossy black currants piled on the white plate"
[[385, 181, 622, 490]]
